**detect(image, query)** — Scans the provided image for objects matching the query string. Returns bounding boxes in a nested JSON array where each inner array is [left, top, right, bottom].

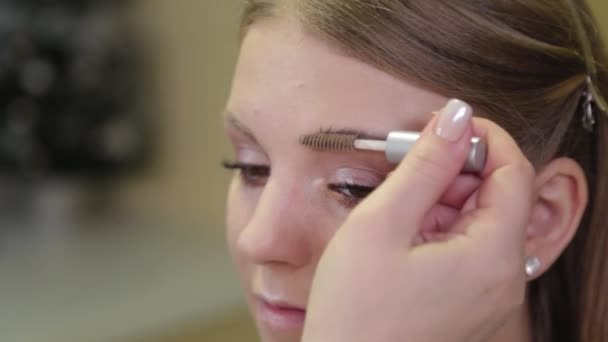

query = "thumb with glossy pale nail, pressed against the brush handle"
[[353, 99, 473, 244]]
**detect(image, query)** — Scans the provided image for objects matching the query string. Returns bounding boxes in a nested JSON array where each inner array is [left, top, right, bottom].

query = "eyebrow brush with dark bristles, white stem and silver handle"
[[300, 131, 487, 172]]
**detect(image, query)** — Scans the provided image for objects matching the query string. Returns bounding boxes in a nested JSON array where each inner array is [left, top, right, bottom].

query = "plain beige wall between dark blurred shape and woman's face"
[[123, 0, 608, 231]]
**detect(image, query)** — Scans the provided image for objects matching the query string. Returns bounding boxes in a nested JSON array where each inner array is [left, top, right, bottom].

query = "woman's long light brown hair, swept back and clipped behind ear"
[[242, 0, 608, 342]]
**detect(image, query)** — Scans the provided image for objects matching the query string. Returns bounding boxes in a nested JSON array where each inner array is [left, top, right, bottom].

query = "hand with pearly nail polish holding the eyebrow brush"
[[302, 100, 534, 342]]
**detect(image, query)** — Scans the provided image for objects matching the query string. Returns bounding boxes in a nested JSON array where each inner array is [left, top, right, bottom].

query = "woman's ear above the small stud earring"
[[526, 158, 588, 277]]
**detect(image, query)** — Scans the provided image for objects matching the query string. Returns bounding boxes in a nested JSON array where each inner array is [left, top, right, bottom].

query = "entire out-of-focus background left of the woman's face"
[[0, 0, 608, 342]]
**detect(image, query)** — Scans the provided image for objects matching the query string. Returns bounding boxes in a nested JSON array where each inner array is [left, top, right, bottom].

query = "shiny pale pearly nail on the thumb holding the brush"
[[435, 99, 473, 142]]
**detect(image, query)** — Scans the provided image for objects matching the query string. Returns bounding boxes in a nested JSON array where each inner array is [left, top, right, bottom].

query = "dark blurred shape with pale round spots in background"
[[0, 0, 150, 177]]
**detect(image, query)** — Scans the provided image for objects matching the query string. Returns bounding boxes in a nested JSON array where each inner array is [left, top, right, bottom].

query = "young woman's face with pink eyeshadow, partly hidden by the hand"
[[225, 19, 447, 342]]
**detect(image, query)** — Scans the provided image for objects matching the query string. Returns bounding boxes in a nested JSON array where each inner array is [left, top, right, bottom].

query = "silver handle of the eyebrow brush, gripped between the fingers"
[[385, 131, 488, 173]]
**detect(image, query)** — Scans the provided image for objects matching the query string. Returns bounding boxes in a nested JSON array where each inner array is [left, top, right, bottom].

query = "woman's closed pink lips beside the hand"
[[256, 297, 306, 330]]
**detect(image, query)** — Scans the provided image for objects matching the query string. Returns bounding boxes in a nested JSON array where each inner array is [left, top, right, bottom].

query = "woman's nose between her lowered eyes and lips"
[[237, 180, 312, 267]]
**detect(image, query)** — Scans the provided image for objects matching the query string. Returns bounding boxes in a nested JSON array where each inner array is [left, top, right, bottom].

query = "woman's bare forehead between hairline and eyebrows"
[[228, 20, 447, 140]]
